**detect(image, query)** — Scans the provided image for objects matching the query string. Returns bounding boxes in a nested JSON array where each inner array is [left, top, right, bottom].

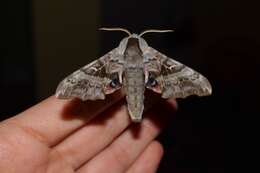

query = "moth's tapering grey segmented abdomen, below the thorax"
[[123, 68, 145, 122]]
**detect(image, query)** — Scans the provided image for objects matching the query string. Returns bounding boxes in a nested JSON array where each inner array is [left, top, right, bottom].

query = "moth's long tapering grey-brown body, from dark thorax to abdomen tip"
[[123, 38, 145, 121]]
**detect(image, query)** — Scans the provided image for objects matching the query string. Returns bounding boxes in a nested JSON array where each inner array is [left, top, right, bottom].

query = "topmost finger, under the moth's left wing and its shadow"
[[4, 92, 123, 146]]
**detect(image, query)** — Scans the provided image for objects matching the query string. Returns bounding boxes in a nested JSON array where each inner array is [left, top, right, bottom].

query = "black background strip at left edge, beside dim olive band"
[[0, 0, 36, 120]]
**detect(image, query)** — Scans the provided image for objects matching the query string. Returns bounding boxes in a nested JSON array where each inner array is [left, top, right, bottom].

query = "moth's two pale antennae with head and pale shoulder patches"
[[99, 28, 173, 54]]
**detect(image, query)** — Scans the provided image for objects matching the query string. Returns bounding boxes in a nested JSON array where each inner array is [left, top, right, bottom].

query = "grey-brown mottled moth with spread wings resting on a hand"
[[55, 28, 212, 122]]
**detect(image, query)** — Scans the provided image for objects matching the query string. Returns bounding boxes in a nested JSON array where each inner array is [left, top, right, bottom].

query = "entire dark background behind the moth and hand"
[[0, 0, 260, 173]]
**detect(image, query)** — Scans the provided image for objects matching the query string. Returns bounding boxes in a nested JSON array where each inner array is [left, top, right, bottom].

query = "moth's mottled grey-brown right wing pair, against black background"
[[144, 47, 212, 98]]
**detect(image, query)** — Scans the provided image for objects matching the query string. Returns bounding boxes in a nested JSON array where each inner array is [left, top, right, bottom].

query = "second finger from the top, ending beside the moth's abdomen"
[[52, 93, 172, 169]]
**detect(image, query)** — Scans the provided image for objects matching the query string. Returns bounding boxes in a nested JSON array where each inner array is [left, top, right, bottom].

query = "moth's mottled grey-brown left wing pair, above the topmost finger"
[[55, 48, 122, 100]]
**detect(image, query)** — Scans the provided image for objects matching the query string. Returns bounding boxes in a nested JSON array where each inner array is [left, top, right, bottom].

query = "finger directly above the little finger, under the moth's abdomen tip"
[[78, 99, 176, 173]]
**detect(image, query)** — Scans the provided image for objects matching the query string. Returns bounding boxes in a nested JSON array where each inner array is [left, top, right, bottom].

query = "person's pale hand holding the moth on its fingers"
[[0, 93, 176, 173]]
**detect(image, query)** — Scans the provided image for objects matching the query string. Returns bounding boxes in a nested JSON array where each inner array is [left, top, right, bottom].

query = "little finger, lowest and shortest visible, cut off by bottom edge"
[[126, 141, 163, 173]]
